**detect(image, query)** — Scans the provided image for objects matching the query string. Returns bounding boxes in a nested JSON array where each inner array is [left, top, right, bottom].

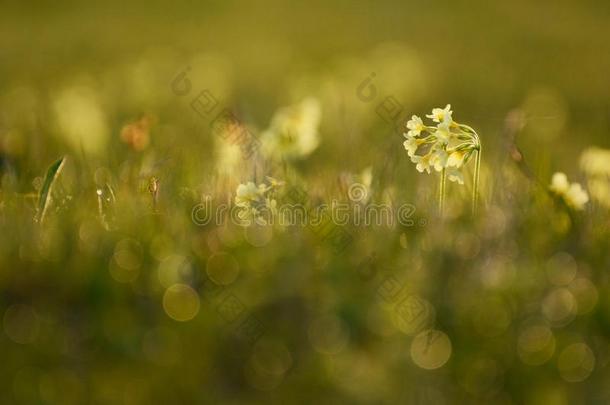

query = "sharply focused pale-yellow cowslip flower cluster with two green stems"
[[403, 104, 481, 216]]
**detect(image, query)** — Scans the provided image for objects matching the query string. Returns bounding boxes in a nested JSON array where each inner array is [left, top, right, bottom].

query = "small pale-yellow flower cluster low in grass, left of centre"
[[235, 177, 284, 226]]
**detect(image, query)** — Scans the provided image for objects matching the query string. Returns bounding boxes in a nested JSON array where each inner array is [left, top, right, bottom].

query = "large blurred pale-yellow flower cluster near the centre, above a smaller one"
[[261, 98, 321, 159]]
